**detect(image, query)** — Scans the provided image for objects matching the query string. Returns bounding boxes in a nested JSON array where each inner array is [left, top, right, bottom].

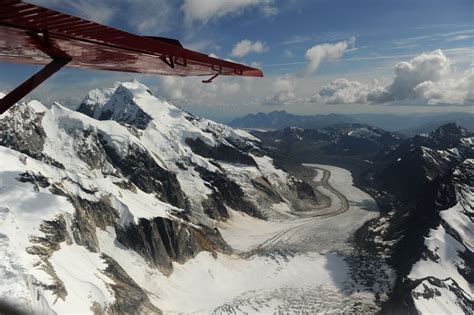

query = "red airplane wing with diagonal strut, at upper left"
[[0, 0, 263, 114]]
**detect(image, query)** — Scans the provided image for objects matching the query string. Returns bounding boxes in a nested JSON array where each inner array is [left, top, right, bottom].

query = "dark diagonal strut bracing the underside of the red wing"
[[0, 58, 71, 115]]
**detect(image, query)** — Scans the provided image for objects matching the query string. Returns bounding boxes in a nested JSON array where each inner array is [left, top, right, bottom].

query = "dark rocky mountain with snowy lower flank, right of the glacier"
[[367, 123, 474, 314]]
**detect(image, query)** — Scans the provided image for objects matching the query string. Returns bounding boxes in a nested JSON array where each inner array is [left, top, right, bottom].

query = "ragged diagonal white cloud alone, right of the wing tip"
[[304, 37, 356, 75]]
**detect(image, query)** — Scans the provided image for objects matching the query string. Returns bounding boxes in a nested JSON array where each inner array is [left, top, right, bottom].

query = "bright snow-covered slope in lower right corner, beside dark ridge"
[[408, 159, 474, 314]]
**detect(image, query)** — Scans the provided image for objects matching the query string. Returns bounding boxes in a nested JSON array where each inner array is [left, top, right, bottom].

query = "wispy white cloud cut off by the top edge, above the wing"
[[181, 0, 278, 24]]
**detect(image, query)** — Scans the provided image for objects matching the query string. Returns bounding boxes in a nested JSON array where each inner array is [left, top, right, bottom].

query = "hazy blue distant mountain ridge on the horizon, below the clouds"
[[229, 111, 358, 130]]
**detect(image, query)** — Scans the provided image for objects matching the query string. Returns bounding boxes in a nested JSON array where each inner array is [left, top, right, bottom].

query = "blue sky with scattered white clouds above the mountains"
[[0, 0, 474, 121]]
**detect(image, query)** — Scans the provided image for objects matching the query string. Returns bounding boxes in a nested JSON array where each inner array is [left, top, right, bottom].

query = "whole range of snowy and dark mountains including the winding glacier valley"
[[0, 81, 474, 314]]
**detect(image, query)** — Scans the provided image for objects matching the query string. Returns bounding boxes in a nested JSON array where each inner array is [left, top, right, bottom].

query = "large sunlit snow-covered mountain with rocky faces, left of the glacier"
[[0, 81, 316, 314]]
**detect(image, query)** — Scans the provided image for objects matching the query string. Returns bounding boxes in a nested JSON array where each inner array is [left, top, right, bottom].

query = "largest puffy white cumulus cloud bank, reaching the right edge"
[[312, 49, 474, 105]]
